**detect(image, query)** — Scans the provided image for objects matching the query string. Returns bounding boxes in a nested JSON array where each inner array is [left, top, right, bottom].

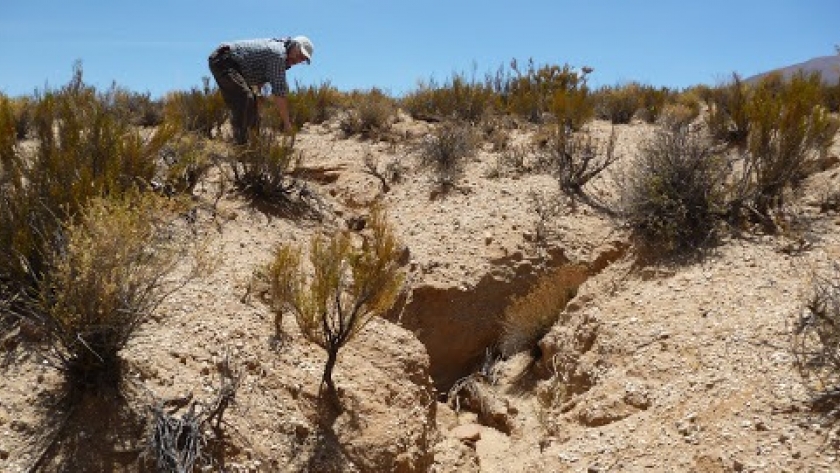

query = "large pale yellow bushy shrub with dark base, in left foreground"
[[14, 194, 201, 392]]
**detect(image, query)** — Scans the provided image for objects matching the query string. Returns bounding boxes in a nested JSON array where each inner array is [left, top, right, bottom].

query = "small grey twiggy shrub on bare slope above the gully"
[[419, 121, 478, 189]]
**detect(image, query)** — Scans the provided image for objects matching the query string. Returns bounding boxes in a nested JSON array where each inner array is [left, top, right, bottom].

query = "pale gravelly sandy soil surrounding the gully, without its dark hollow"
[[0, 112, 840, 473]]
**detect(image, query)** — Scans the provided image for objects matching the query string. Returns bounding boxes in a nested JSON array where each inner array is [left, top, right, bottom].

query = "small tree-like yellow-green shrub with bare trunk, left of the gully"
[[263, 208, 403, 394]]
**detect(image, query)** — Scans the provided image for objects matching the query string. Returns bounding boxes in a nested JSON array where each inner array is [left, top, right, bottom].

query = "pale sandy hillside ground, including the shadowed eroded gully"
[[0, 79, 840, 473]]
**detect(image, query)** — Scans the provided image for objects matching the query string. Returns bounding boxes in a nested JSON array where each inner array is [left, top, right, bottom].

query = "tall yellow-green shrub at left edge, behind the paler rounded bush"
[[0, 65, 173, 297]]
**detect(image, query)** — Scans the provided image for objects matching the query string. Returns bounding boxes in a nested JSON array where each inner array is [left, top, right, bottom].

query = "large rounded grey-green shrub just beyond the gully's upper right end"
[[621, 122, 729, 256]]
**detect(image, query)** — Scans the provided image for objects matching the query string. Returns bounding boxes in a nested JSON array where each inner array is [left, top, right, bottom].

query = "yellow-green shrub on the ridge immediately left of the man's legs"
[[163, 77, 228, 138]]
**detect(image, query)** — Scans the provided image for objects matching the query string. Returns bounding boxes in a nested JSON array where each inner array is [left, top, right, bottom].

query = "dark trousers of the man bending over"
[[208, 46, 259, 144]]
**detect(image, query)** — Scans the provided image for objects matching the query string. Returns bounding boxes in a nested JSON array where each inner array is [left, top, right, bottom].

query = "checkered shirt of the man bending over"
[[226, 38, 289, 96]]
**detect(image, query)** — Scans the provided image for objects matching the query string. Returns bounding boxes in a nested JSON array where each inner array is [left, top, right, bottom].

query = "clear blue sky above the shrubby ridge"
[[0, 0, 840, 96]]
